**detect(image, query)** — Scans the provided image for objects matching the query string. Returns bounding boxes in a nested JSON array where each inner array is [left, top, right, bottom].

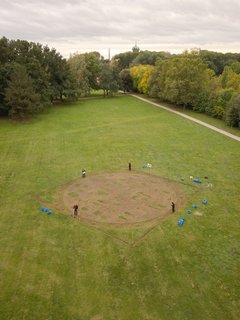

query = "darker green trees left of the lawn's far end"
[[0, 37, 120, 119]]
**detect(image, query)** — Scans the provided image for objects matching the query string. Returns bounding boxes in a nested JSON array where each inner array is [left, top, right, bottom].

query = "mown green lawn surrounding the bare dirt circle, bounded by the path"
[[0, 97, 240, 320]]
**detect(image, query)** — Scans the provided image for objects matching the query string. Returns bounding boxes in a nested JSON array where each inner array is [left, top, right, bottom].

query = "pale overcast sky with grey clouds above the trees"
[[0, 0, 240, 58]]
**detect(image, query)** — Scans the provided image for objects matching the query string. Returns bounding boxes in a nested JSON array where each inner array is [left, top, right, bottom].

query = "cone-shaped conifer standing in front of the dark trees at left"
[[5, 64, 40, 119]]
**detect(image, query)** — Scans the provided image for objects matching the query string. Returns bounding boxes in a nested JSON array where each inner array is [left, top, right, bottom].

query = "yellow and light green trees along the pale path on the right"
[[115, 50, 240, 128]]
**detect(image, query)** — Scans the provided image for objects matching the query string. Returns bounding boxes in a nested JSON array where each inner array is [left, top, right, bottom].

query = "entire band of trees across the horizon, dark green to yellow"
[[0, 37, 240, 127]]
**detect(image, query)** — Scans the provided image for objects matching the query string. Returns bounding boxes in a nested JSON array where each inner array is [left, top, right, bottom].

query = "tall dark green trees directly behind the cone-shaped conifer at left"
[[0, 37, 75, 114]]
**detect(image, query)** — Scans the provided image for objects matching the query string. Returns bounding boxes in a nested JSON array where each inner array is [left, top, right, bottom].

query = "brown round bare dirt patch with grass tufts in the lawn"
[[62, 171, 184, 224]]
